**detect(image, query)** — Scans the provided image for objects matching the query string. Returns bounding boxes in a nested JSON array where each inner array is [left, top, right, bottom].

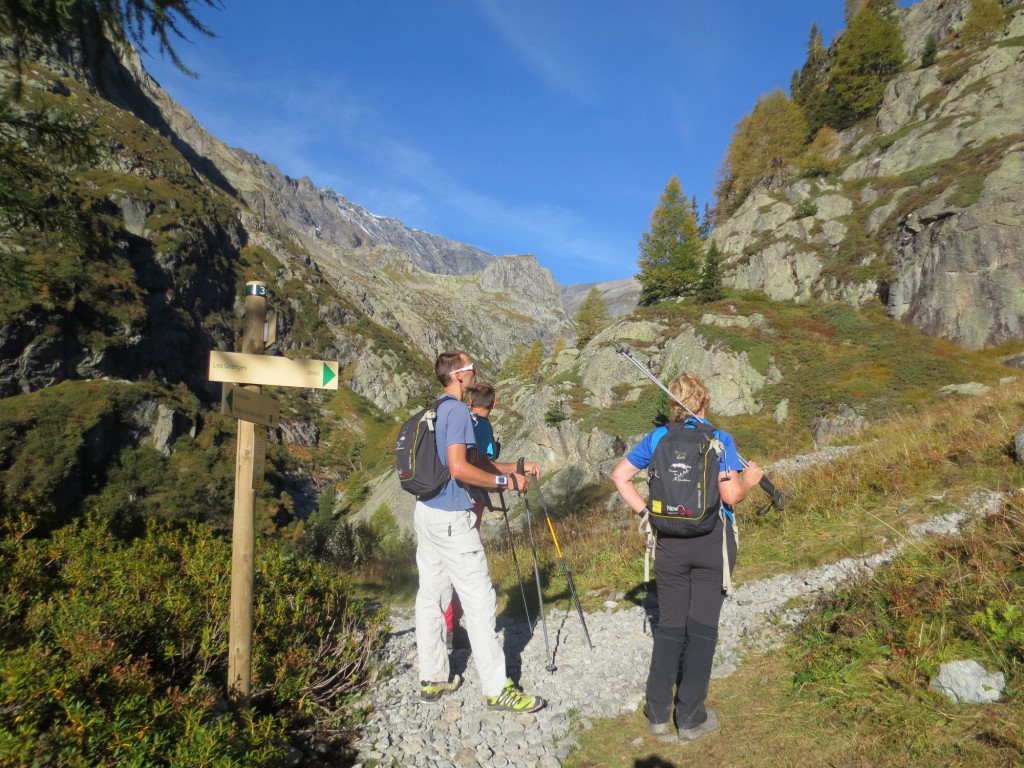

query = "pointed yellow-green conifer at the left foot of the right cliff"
[[637, 176, 703, 306]]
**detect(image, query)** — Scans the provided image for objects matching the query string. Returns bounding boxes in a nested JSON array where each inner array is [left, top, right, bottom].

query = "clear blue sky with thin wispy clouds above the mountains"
[[143, 0, 888, 285]]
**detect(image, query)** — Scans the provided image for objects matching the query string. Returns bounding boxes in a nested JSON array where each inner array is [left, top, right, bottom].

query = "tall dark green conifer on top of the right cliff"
[[804, 0, 903, 132]]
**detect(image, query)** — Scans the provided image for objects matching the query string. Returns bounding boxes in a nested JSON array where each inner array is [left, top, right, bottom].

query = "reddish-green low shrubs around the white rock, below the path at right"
[[795, 511, 1024, 716]]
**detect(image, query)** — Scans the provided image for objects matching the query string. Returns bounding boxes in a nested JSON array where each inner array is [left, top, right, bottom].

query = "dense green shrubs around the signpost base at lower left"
[[0, 517, 382, 766]]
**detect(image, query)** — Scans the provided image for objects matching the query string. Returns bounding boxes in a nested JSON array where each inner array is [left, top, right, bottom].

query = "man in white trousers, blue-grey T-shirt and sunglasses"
[[414, 350, 546, 712]]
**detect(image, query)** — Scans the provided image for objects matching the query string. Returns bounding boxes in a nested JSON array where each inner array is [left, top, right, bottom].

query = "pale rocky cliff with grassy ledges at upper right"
[[714, 0, 1024, 349]]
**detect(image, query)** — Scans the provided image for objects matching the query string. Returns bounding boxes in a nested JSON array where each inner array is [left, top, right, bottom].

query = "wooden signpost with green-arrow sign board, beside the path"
[[210, 281, 338, 700]]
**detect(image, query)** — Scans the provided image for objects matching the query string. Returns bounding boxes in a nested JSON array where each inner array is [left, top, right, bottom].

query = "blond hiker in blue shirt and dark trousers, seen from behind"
[[611, 374, 763, 741]]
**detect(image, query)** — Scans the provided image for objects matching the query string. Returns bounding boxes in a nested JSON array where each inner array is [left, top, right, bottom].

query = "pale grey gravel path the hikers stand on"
[[357, 494, 999, 768]]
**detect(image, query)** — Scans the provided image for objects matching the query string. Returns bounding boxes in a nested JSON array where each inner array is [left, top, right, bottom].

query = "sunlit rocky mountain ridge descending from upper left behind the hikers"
[[126, 55, 571, 403]]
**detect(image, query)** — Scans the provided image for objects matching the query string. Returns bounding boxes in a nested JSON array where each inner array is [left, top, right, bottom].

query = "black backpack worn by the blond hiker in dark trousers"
[[647, 420, 722, 538]]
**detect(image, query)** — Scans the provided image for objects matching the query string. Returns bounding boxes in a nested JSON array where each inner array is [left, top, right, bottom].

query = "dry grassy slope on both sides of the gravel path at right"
[[568, 384, 1024, 768]]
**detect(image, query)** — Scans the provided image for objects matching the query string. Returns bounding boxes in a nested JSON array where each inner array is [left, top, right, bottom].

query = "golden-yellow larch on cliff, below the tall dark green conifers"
[[715, 89, 807, 215]]
